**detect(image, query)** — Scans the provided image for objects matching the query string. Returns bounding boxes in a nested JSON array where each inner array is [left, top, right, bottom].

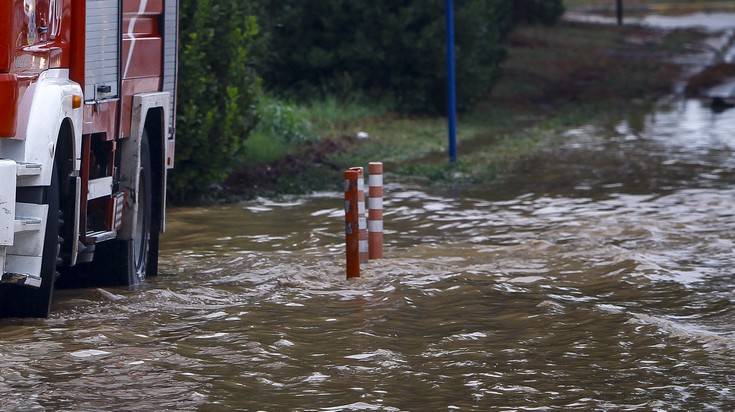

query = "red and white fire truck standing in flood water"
[[0, 0, 178, 317]]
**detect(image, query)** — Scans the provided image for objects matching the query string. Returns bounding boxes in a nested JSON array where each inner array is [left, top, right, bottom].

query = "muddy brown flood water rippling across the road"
[[0, 14, 735, 411]]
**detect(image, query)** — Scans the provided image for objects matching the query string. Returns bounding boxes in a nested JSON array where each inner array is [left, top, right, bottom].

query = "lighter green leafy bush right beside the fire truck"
[[169, 0, 262, 200]]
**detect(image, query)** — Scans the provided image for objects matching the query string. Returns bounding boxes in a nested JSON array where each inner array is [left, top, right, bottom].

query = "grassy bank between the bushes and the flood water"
[[224, 23, 703, 198]]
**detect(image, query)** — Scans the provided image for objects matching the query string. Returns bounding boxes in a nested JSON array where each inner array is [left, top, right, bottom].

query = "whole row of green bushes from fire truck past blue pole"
[[170, 0, 563, 200]]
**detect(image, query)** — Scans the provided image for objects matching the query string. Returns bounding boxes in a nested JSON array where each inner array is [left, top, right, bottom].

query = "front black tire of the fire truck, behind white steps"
[[0, 159, 63, 318]]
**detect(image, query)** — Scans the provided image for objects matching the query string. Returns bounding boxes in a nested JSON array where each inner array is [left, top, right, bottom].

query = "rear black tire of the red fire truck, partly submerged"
[[87, 131, 158, 286]]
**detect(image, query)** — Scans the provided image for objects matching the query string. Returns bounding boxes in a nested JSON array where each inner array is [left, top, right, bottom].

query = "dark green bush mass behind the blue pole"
[[261, 0, 513, 112]]
